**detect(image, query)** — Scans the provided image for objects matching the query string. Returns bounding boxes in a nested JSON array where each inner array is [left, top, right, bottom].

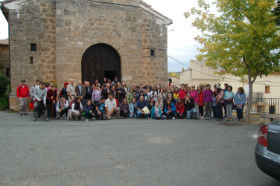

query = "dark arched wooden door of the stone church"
[[82, 44, 121, 83]]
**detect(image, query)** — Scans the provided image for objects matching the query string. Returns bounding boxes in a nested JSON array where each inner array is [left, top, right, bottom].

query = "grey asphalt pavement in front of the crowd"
[[0, 112, 280, 186]]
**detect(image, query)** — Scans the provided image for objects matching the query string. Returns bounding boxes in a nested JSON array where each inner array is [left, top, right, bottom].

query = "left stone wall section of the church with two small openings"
[[9, 0, 56, 93]]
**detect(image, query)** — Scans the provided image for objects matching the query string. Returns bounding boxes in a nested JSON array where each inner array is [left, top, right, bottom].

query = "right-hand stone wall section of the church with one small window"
[[142, 10, 168, 85]]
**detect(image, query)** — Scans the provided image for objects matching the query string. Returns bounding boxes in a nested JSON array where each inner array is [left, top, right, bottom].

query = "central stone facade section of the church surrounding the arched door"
[[56, 0, 143, 86]]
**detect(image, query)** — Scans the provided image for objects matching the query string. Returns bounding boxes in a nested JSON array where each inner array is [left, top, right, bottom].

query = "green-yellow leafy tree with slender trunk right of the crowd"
[[185, 0, 280, 119]]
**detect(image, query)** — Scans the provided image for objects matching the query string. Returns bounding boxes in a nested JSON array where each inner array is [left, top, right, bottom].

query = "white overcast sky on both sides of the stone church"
[[0, 0, 198, 72]]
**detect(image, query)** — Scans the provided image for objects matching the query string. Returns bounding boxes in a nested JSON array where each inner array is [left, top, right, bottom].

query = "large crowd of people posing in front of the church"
[[17, 78, 246, 121]]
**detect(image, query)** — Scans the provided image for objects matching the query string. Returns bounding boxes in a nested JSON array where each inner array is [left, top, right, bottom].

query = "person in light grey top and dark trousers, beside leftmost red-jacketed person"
[[33, 83, 48, 121]]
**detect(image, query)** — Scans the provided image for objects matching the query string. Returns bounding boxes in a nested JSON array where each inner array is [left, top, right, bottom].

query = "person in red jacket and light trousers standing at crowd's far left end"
[[17, 80, 30, 116]]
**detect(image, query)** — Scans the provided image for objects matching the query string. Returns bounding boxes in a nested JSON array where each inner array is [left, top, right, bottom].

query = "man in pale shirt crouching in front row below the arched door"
[[105, 94, 120, 120]]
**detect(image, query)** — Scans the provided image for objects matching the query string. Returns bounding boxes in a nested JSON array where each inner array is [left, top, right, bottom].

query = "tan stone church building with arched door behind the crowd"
[[1, 0, 172, 109]]
